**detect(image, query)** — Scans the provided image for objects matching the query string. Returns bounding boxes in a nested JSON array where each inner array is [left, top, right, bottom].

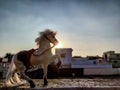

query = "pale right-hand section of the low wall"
[[84, 68, 120, 75]]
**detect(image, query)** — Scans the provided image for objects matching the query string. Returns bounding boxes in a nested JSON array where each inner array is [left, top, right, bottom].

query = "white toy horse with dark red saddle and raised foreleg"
[[6, 29, 61, 88]]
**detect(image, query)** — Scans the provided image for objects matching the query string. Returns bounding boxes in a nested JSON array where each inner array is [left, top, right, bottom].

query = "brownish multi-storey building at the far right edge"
[[103, 51, 120, 68]]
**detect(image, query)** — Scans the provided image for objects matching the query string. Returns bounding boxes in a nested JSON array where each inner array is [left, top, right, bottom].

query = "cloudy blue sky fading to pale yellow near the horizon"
[[0, 0, 120, 56]]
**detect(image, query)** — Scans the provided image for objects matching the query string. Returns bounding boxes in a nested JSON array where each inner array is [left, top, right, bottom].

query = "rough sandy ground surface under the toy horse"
[[0, 78, 120, 88]]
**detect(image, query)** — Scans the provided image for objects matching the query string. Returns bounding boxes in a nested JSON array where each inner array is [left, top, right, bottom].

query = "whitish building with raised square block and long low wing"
[[56, 48, 112, 68]]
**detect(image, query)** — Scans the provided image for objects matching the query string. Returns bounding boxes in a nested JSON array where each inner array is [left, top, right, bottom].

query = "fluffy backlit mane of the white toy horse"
[[35, 29, 57, 45]]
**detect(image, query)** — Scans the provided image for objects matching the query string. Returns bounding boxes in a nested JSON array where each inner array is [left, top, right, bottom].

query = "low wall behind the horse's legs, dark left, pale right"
[[27, 68, 120, 79]]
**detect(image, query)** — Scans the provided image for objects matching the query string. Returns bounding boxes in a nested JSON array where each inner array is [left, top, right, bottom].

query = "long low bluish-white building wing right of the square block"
[[71, 58, 112, 69]]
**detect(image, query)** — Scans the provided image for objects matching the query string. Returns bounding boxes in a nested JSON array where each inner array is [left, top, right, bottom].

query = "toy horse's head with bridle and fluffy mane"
[[35, 29, 58, 45]]
